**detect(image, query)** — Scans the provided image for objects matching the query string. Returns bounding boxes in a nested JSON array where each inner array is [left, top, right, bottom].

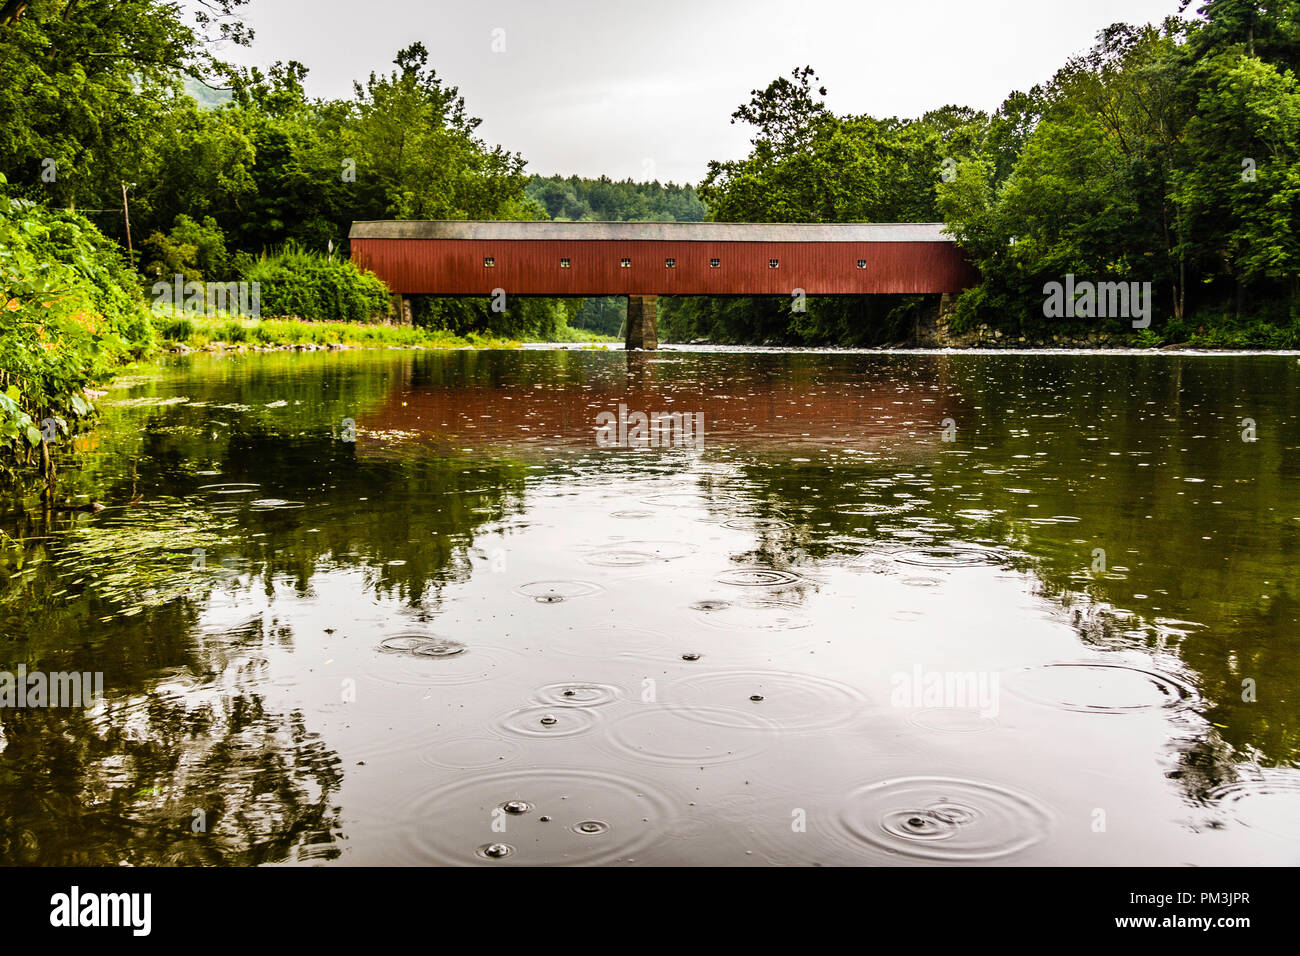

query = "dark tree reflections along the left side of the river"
[[0, 356, 524, 865]]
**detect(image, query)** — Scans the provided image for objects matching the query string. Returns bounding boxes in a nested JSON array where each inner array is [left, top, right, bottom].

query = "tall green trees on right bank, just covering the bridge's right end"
[[939, 0, 1300, 346]]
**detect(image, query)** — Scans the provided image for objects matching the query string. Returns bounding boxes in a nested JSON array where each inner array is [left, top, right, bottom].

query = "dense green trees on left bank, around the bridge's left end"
[[0, 0, 600, 353]]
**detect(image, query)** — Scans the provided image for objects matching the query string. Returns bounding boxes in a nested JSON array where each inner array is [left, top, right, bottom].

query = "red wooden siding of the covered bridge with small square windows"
[[352, 237, 976, 295]]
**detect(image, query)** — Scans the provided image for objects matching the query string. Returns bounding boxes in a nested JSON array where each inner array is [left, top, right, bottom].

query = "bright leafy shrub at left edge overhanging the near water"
[[0, 176, 155, 468]]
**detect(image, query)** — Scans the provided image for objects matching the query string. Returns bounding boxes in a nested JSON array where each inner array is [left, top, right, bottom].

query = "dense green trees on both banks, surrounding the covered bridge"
[[0, 0, 1300, 374]]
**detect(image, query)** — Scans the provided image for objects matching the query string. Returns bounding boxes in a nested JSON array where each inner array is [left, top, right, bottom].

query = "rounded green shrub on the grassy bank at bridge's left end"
[[241, 245, 389, 323]]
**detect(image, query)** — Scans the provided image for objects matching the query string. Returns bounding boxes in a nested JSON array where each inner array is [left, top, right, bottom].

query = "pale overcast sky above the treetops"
[[225, 0, 1178, 183]]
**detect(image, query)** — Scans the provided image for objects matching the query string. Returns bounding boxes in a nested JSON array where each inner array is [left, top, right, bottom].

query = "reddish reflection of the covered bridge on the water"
[[358, 350, 962, 453]]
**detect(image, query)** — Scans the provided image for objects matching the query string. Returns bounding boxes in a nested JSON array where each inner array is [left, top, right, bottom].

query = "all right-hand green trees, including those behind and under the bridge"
[[663, 0, 1300, 347]]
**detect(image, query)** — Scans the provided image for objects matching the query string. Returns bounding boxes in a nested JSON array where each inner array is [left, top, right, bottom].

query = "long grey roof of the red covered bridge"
[[348, 220, 953, 242]]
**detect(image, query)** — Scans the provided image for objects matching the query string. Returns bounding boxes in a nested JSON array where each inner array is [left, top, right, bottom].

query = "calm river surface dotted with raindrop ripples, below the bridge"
[[0, 350, 1300, 866]]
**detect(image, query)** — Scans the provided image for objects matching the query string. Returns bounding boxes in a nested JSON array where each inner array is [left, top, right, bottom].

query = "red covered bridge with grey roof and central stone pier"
[[350, 220, 976, 349]]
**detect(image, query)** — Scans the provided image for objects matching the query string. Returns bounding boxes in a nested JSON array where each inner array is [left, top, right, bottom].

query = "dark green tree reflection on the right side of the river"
[[718, 356, 1300, 799]]
